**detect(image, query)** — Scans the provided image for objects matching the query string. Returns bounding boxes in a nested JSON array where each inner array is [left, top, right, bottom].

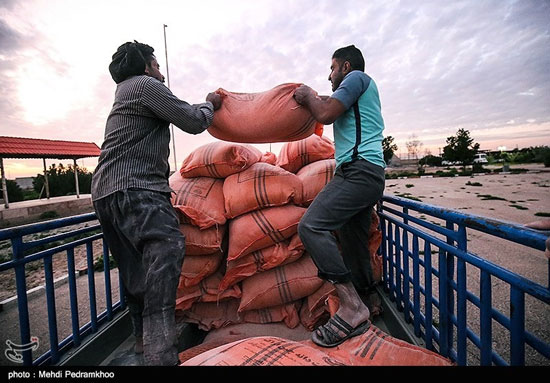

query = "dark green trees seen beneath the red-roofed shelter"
[[33, 163, 92, 197]]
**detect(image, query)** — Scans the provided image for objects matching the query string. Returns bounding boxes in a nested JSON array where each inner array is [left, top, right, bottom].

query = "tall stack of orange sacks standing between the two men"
[[170, 135, 382, 330]]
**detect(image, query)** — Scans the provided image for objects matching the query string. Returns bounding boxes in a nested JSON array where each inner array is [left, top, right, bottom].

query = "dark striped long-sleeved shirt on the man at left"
[[92, 75, 214, 201]]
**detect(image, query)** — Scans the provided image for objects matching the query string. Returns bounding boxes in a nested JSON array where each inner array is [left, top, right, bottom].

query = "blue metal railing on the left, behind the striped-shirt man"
[[0, 213, 126, 366]]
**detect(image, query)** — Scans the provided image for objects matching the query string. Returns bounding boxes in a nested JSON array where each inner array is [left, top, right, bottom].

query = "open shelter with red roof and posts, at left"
[[0, 136, 101, 208]]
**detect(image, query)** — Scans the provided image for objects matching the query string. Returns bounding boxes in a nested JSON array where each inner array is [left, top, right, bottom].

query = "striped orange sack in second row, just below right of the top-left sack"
[[223, 162, 302, 218]]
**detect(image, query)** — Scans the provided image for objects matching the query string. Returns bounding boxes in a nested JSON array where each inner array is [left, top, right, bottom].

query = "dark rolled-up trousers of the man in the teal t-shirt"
[[298, 159, 385, 293]]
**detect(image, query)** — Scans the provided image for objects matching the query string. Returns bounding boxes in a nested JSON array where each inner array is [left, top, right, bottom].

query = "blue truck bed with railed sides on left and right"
[[0, 195, 550, 366]]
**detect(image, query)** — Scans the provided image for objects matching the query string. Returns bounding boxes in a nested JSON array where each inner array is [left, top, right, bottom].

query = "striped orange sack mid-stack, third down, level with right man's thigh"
[[227, 205, 306, 261]]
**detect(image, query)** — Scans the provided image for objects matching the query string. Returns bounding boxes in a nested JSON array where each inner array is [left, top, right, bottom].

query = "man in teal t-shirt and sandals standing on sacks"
[[294, 45, 386, 347]]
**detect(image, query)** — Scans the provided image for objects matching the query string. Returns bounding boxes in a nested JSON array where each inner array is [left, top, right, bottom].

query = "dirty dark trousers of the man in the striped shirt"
[[94, 189, 185, 366]]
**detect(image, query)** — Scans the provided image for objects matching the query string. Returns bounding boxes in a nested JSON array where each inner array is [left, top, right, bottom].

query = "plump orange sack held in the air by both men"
[[208, 83, 323, 144]]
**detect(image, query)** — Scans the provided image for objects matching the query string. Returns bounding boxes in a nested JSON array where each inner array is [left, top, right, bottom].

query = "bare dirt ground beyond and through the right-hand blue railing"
[[385, 167, 550, 365]]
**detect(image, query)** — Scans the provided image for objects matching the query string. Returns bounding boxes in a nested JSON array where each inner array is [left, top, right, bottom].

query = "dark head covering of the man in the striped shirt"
[[109, 40, 155, 84]]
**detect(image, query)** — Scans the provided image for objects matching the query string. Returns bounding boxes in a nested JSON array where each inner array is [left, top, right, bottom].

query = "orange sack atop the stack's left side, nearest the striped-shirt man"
[[180, 142, 262, 178]]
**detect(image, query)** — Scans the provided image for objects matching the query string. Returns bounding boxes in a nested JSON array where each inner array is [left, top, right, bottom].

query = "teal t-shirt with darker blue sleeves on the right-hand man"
[[331, 70, 386, 168]]
